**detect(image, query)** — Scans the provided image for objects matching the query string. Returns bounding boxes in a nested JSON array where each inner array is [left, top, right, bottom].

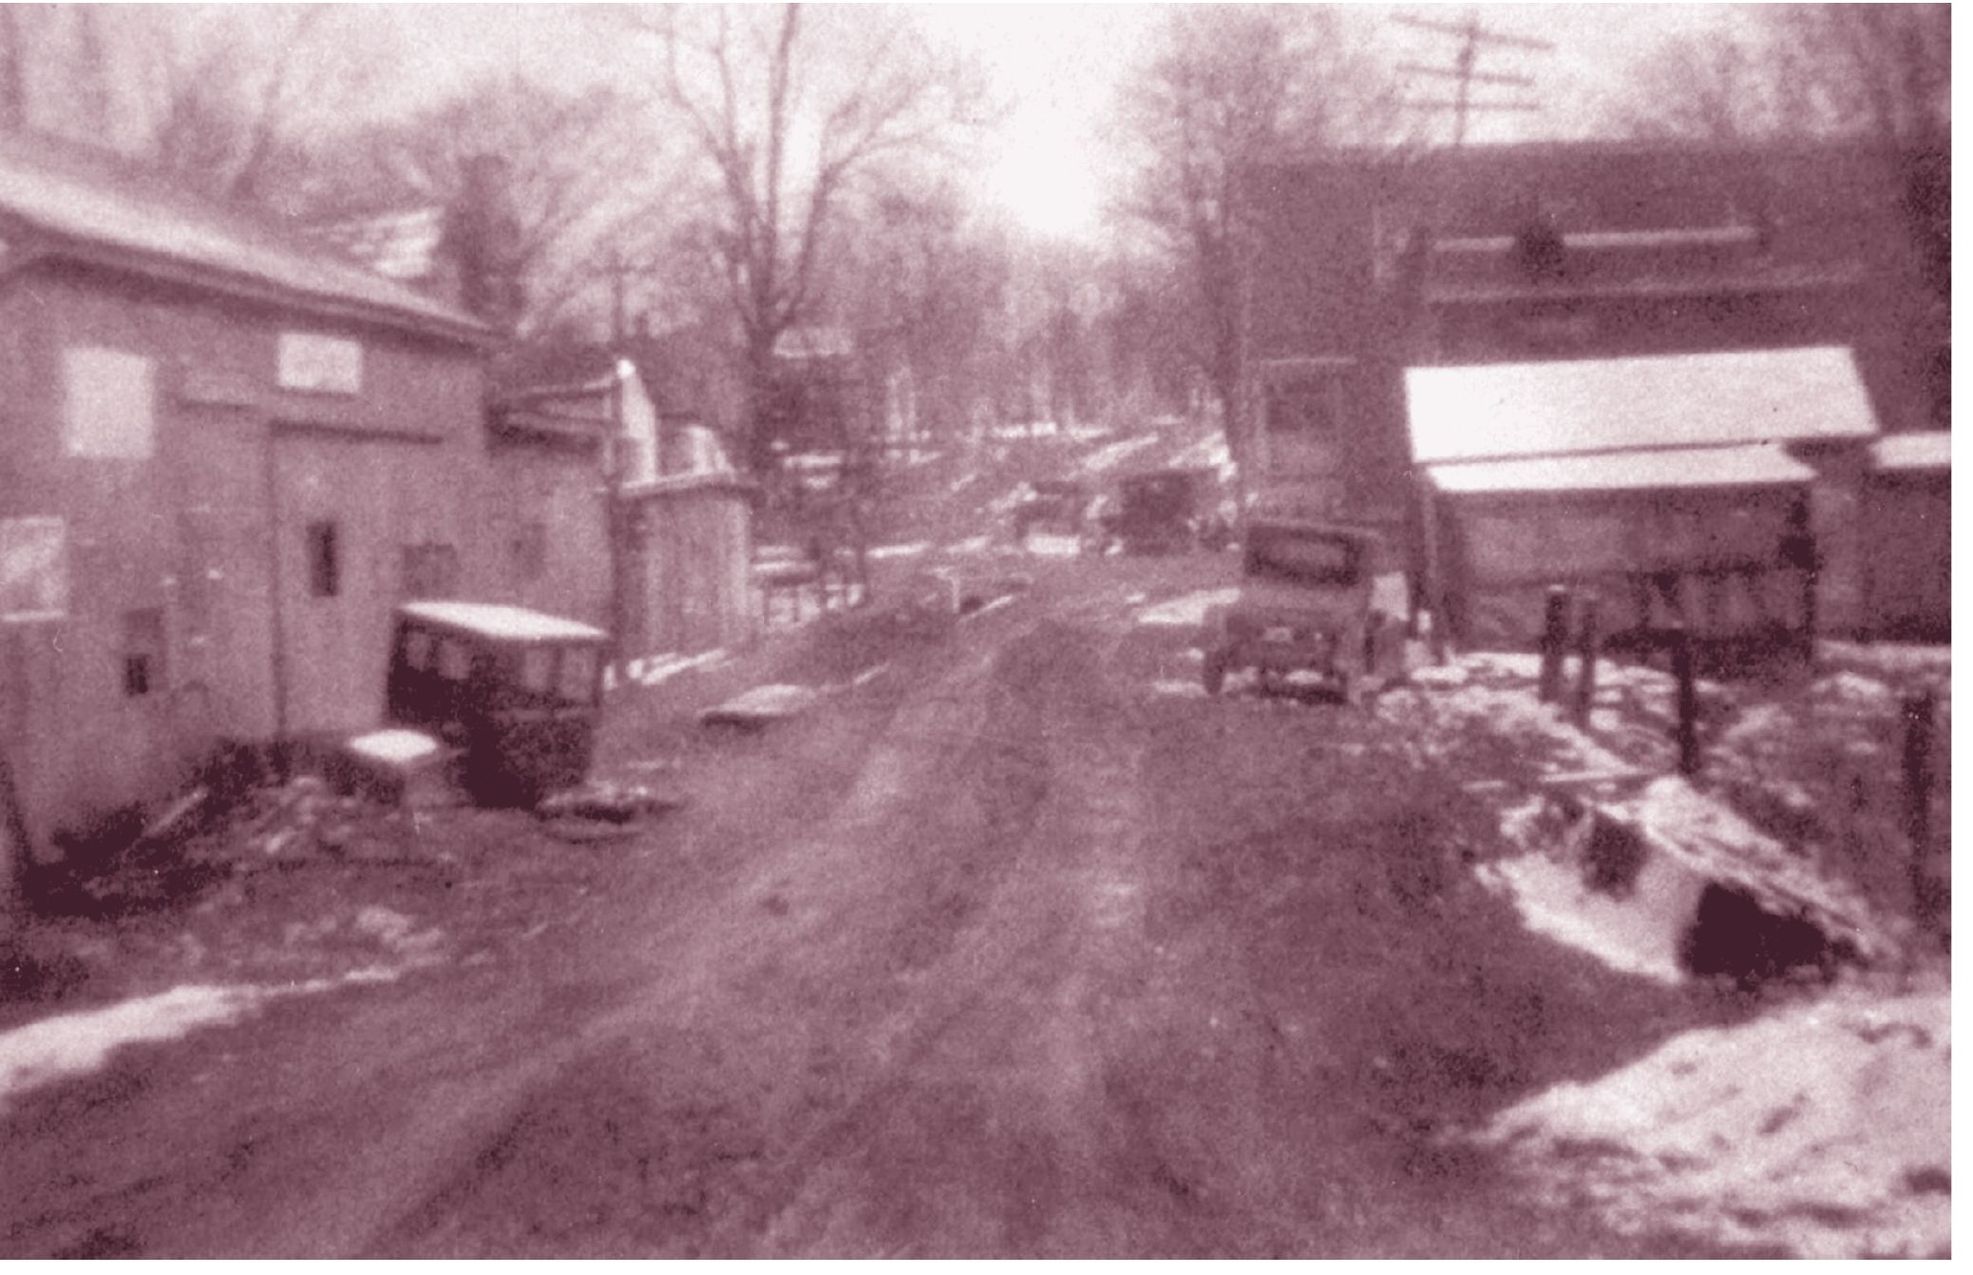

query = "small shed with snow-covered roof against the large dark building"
[[1407, 347, 1874, 643]]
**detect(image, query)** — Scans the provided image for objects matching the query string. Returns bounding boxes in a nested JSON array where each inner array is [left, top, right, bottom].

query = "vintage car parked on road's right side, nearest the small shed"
[[1200, 517, 1409, 705]]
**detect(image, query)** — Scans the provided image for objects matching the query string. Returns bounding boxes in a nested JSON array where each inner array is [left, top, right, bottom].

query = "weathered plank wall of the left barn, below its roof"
[[0, 270, 481, 845]]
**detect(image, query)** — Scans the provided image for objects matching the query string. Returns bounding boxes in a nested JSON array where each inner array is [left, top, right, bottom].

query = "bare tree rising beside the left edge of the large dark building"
[[1123, 6, 1397, 495]]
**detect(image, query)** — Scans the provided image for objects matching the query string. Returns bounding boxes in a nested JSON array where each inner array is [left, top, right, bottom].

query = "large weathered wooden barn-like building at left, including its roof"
[[0, 142, 489, 860]]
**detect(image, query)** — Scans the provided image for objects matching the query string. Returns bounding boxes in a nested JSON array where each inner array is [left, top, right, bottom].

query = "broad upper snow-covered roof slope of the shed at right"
[[1405, 345, 1876, 464]]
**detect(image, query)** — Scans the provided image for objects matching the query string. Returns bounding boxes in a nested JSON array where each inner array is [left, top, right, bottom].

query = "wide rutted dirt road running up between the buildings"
[[0, 561, 1759, 1257]]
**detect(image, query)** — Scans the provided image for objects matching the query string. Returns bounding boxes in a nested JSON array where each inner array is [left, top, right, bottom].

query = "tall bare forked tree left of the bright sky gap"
[[645, 4, 961, 470]]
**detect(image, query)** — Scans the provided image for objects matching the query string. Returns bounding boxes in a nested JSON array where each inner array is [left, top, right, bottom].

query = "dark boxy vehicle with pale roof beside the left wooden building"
[[385, 602, 608, 805]]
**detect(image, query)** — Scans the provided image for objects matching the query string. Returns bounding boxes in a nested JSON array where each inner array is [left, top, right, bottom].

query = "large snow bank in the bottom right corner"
[[1478, 991, 1951, 1257]]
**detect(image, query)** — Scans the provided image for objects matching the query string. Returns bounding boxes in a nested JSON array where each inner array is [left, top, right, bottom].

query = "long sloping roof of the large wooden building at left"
[[0, 140, 487, 339]]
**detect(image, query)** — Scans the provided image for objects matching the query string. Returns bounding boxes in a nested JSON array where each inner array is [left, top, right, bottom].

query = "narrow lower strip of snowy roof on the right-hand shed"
[[1426, 444, 1815, 495]]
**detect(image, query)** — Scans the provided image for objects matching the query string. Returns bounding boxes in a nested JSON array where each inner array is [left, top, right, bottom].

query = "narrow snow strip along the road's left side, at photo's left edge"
[[0, 969, 397, 1111]]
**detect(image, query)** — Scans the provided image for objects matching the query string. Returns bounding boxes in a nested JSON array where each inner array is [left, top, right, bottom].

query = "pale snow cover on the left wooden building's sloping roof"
[[0, 146, 483, 332]]
